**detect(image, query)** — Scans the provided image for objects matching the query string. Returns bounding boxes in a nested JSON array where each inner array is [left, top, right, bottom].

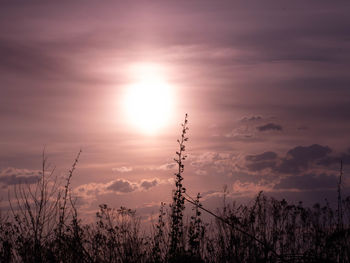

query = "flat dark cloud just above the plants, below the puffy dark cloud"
[[274, 173, 337, 190]]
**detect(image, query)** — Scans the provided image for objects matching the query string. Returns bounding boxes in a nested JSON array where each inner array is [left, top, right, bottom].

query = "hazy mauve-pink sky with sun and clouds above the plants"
[[0, 1, 350, 223]]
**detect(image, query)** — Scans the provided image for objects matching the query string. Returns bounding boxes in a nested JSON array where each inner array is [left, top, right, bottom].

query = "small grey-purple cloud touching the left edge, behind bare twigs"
[[0, 167, 41, 186]]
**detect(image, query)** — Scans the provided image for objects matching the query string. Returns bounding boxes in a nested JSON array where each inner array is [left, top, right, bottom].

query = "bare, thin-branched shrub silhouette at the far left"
[[9, 151, 60, 262]]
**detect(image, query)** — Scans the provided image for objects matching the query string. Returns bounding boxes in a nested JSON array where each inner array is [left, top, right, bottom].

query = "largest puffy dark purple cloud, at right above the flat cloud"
[[275, 144, 332, 174]]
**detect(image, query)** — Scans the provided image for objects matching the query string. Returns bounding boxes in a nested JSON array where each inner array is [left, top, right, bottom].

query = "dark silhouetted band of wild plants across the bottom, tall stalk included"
[[0, 114, 350, 263]]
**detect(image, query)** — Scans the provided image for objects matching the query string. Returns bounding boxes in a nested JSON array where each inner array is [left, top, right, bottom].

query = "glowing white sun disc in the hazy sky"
[[123, 64, 174, 134]]
